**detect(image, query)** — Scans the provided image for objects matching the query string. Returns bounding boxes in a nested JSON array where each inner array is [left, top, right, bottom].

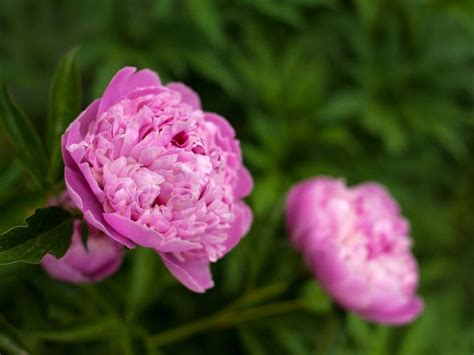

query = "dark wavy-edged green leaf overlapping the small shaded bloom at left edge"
[[0, 206, 75, 265]]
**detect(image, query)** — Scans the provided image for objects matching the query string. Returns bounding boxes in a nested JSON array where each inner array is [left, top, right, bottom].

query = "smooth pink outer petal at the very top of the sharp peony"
[[97, 67, 161, 116]]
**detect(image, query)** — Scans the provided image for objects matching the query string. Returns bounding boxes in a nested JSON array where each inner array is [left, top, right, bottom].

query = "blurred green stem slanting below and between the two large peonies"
[[150, 299, 306, 347]]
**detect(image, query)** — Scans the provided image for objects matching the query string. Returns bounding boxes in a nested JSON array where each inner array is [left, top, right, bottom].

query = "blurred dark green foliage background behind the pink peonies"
[[0, 0, 474, 355]]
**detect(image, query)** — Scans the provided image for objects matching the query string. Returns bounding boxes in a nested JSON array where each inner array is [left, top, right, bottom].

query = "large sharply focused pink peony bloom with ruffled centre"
[[62, 68, 253, 292]]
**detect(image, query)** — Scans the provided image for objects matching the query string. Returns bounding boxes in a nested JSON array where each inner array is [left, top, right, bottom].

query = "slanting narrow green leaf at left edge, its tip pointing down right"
[[0, 85, 48, 187]]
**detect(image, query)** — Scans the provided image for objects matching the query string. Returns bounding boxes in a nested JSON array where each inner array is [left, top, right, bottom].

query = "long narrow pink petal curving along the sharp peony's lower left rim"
[[104, 213, 202, 253]]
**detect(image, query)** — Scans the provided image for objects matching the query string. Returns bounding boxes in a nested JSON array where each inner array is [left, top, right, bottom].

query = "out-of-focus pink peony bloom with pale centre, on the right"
[[286, 177, 423, 324]]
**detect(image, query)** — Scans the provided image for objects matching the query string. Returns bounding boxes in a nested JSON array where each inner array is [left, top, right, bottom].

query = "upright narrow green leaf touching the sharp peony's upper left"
[[46, 49, 82, 181]]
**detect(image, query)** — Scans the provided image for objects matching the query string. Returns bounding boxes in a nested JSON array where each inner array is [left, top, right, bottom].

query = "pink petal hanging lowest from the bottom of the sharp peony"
[[160, 253, 214, 293]]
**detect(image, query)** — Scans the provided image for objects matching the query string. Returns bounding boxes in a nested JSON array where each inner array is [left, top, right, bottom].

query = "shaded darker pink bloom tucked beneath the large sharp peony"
[[41, 192, 123, 283]]
